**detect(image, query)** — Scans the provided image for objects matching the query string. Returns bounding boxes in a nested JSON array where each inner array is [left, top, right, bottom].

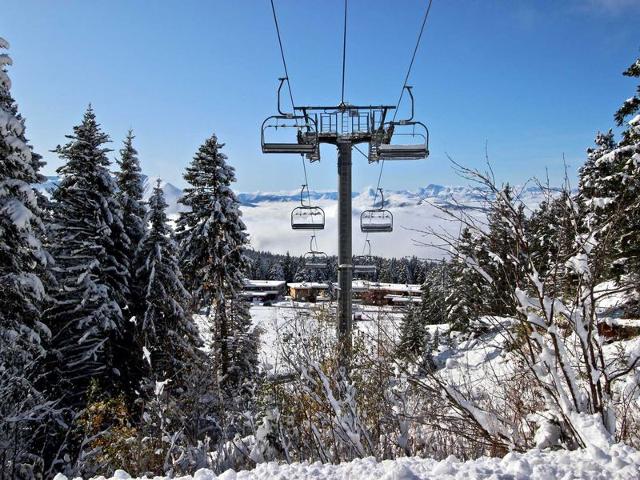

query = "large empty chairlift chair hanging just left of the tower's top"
[[261, 77, 320, 161]]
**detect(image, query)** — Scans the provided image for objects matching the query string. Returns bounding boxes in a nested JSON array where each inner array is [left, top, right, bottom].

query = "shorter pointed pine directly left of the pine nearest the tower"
[[135, 181, 201, 383]]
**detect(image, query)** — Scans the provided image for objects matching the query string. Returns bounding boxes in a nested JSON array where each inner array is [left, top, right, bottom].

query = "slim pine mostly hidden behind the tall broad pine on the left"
[[116, 130, 146, 318]]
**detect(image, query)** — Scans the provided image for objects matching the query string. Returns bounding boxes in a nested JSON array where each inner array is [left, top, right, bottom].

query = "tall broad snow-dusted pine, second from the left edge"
[[47, 106, 142, 412]]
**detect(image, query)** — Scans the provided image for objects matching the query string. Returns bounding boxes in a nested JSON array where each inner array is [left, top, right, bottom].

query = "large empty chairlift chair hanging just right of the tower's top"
[[369, 86, 429, 161]]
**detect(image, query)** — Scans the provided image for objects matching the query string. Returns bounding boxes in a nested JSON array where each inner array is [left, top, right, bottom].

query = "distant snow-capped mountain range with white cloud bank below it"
[[37, 177, 543, 258]]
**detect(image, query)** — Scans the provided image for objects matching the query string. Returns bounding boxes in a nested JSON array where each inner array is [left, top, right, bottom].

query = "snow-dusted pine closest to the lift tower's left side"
[[177, 135, 255, 378]]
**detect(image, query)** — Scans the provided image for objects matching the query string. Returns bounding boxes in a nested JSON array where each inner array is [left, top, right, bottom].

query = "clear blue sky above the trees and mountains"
[[0, 0, 640, 191]]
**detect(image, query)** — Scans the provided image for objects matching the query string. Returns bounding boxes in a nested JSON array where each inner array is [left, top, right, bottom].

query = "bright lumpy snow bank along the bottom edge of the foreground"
[[54, 444, 640, 480]]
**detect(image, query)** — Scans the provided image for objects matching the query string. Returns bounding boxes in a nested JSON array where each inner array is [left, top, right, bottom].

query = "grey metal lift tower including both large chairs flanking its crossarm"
[[261, 77, 429, 370]]
